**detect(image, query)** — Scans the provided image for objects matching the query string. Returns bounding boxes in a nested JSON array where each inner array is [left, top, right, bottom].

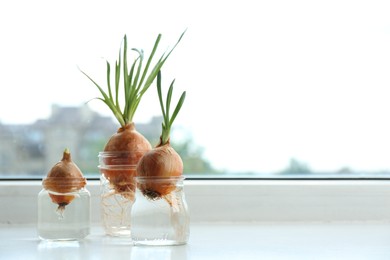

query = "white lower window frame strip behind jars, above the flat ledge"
[[0, 180, 390, 224]]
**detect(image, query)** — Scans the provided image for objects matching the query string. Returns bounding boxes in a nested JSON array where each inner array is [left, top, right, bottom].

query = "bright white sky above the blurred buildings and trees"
[[0, 0, 390, 172]]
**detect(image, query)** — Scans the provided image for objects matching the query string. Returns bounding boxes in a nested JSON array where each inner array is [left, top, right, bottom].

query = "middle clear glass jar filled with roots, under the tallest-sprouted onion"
[[98, 150, 145, 237]]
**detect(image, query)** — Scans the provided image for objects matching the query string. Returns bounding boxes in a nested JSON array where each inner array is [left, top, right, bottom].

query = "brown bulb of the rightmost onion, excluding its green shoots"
[[137, 142, 183, 199]]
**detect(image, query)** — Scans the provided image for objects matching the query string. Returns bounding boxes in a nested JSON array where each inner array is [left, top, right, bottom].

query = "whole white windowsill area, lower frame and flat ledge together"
[[0, 180, 390, 260]]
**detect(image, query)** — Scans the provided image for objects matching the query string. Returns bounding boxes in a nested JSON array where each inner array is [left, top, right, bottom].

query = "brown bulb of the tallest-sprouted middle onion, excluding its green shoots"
[[101, 123, 152, 199]]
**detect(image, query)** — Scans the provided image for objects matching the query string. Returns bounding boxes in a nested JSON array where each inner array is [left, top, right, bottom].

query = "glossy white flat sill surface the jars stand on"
[[0, 222, 390, 260]]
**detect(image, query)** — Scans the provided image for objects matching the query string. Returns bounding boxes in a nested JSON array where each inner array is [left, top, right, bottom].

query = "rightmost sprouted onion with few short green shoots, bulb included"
[[137, 72, 186, 204]]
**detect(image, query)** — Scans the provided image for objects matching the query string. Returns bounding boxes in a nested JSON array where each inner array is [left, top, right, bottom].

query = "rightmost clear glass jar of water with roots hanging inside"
[[131, 177, 190, 245]]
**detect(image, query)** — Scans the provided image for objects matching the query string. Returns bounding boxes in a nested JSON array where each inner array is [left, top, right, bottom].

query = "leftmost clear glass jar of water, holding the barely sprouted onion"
[[38, 180, 91, 240]]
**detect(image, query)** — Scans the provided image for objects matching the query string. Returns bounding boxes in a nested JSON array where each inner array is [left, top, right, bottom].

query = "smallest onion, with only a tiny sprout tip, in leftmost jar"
[[42, 148, 87, 215]]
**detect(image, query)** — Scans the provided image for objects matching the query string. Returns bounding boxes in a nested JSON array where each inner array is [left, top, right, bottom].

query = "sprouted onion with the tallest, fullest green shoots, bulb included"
[[81, 32, 184, 199]]
